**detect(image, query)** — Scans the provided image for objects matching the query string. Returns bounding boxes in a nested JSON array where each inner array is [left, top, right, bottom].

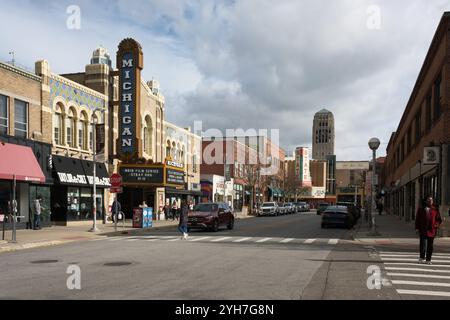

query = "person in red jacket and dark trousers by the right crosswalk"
[[416, 196, 442, 264]]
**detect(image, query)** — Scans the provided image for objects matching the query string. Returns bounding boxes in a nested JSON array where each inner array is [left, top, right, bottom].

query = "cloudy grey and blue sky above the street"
[[0, 0, 450, 160]]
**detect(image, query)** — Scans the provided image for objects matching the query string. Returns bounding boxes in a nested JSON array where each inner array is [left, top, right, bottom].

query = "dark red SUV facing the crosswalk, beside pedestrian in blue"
[[188, 202, 234, 232]]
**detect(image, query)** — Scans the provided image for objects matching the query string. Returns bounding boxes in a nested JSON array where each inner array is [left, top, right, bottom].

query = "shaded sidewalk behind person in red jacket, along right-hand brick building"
[[353, 214, 450, 245]]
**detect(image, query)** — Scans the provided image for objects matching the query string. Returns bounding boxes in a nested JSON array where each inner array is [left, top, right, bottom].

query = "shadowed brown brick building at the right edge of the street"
[[382, 12, 450, 235]]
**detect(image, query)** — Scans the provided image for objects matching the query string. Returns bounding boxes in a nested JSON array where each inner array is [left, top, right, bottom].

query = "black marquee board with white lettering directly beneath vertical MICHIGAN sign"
[[119, 166, 164, 184]]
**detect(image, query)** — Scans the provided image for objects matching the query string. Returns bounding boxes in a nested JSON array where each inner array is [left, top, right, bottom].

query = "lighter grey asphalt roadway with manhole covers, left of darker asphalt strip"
[[0, 213, 352, 300]]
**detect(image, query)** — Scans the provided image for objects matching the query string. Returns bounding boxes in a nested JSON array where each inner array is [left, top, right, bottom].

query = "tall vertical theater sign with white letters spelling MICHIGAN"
[[117, 38, 144, 162]]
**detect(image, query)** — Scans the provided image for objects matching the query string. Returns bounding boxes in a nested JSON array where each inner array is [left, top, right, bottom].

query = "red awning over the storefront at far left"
[[0, 143, 45, 182]]
